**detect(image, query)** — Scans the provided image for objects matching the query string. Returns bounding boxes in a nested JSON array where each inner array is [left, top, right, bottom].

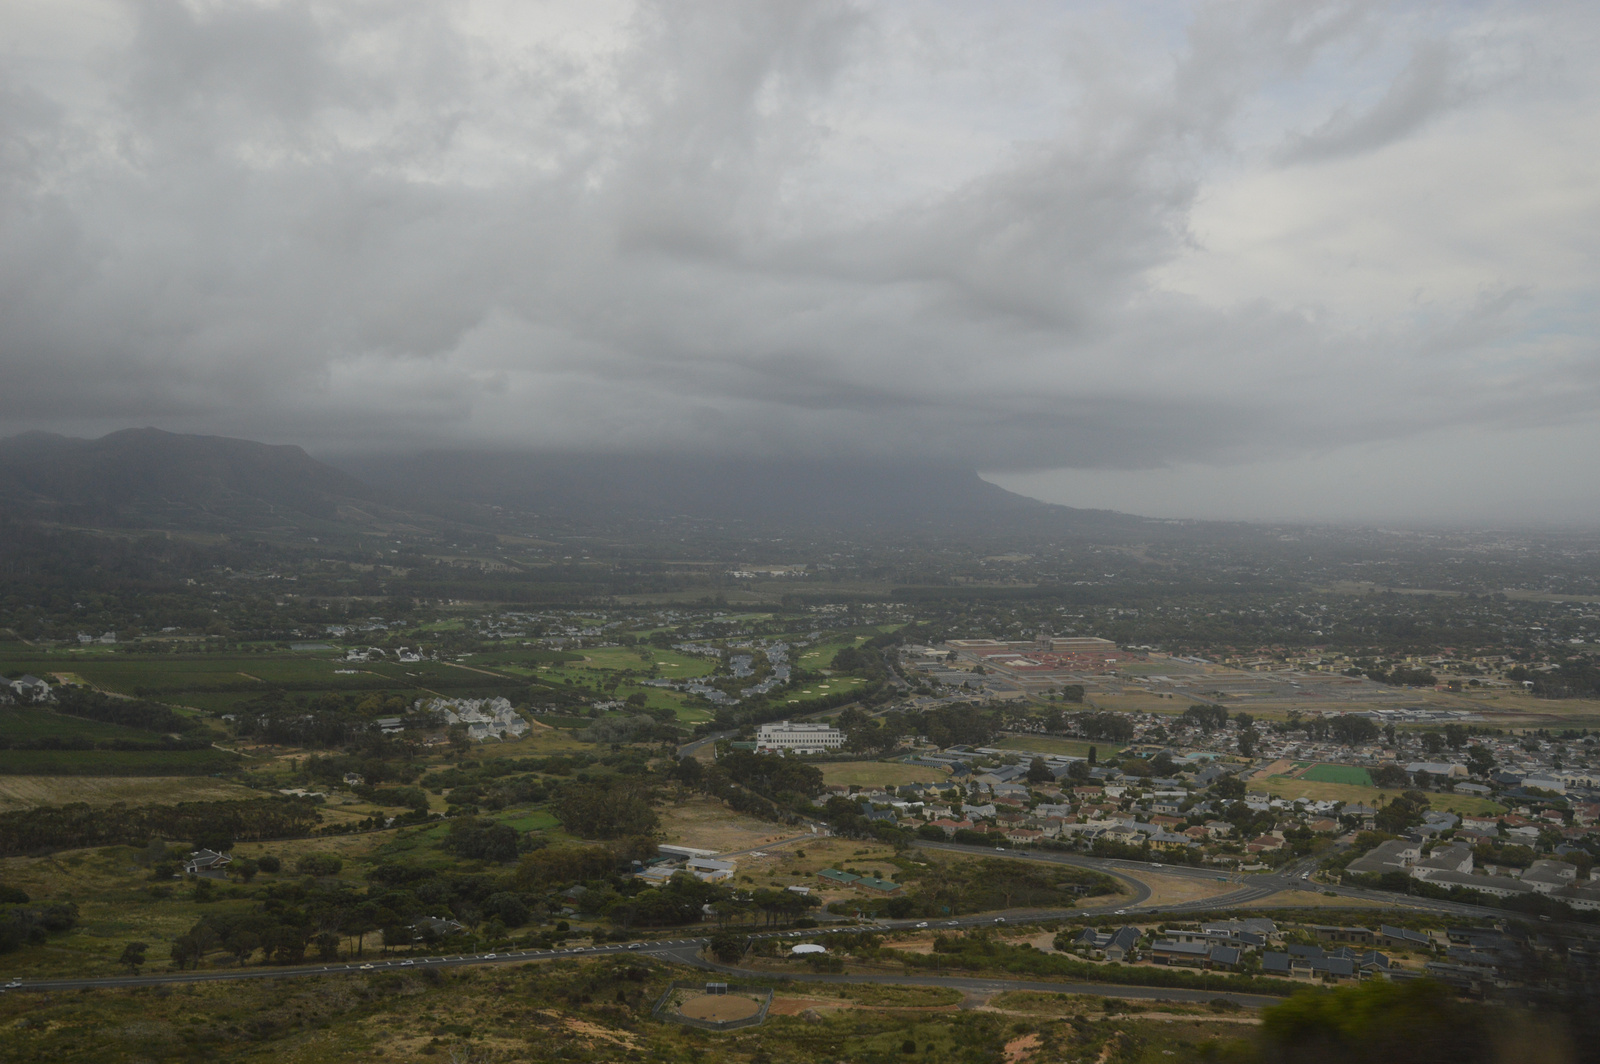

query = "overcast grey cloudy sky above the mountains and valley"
[[0, 0, 1600, 523]]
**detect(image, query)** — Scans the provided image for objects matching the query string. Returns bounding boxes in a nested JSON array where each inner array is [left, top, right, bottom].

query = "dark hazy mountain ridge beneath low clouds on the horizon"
[[0, 427, 1168, 538]]
